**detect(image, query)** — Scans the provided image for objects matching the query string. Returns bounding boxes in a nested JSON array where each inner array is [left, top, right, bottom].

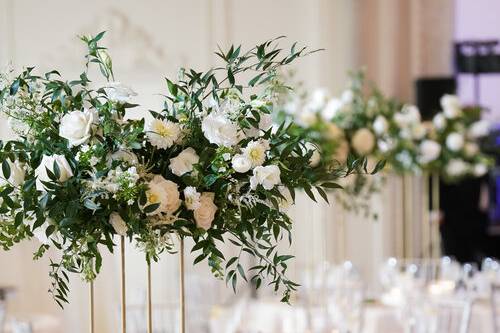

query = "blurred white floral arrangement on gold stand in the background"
[[277, 72, 491, 213]]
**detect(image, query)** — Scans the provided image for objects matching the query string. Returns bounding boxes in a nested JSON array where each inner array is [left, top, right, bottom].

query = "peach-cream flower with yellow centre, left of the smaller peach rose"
[[146, 175, 181, 215]]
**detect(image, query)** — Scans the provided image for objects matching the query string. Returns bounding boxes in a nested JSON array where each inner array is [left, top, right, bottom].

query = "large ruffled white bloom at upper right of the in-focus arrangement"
[[201, 111, 239, 147]]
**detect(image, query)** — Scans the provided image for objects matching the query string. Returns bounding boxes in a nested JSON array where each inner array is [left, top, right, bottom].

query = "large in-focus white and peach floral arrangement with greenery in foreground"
[[0, 33, 359, 306]]
